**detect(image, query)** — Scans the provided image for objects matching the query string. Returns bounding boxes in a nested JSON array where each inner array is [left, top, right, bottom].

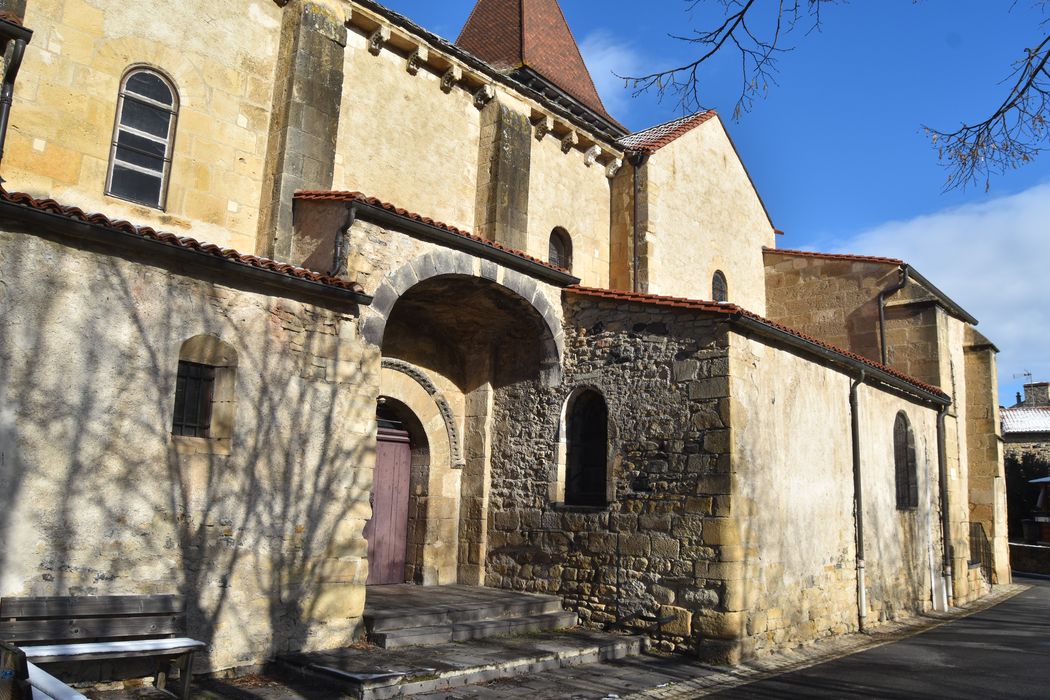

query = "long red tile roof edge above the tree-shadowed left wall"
[[0, 190, 364, 294]]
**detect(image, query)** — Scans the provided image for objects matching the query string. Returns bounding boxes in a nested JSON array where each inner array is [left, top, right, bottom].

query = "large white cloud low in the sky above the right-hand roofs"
[[840, 185, 1050, 405]]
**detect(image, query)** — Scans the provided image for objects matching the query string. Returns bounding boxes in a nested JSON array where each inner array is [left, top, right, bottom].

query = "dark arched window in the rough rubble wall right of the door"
[[565, 389, 609, 506]]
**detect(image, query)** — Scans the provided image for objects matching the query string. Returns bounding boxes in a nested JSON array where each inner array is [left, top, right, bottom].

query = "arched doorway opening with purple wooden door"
[[364, 398, 429, 586]]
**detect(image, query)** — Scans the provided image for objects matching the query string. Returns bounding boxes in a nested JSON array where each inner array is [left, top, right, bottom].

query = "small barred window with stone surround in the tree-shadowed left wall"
[[171, 335, 237, 453]]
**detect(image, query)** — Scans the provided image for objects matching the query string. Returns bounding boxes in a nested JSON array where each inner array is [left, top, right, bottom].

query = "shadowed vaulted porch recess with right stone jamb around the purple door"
[[377, 274, 560, 586]]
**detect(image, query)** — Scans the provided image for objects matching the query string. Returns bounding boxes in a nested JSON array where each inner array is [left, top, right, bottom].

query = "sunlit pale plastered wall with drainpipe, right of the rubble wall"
[[727, 336, 938, 654]]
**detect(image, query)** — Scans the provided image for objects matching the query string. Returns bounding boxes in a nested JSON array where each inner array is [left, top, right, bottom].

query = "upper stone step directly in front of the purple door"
[[364, 594, 562, 636]]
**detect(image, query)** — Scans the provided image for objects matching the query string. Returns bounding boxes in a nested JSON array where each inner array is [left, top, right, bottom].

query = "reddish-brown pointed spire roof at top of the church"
[[456, 0, 615, 124]]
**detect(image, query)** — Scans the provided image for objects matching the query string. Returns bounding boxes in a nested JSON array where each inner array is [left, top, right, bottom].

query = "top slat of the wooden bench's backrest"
[[0, 595, 186, 619]]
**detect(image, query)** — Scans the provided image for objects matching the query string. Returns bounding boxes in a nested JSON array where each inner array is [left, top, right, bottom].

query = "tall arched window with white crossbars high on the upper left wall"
[[106, 68, 179, 209]]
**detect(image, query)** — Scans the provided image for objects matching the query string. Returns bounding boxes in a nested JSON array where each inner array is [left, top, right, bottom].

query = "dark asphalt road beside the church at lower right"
[[708, 577, 1050, 700]]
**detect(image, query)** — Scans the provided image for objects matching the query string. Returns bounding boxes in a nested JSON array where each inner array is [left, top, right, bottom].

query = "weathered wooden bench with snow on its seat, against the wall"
[[0, 595, 206, 700]]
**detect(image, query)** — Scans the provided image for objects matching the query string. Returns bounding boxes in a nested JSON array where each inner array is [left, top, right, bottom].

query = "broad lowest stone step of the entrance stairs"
[[280, 629, 645, 700]]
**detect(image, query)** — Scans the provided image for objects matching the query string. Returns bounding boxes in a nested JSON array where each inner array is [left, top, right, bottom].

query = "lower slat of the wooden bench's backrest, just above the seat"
[[0, 615, 182, 642]]
